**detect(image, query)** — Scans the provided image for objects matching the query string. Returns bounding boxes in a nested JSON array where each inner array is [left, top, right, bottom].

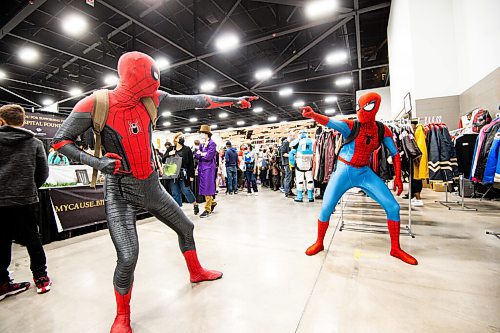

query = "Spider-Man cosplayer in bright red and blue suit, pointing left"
[[302, 93, 418, 265]]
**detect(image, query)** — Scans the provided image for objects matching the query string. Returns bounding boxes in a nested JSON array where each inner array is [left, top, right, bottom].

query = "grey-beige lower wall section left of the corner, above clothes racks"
[[415, 95, 460, 130]]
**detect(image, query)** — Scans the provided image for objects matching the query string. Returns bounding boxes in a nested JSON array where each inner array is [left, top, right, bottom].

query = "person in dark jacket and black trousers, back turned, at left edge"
[[0, 105, 52, 300]]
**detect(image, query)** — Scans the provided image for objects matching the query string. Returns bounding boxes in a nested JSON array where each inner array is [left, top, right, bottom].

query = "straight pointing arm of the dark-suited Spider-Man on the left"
[[158, 90, 258, 111]]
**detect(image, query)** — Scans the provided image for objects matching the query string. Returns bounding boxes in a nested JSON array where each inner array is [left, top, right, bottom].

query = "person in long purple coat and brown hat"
[[195, 125, 217, 218]]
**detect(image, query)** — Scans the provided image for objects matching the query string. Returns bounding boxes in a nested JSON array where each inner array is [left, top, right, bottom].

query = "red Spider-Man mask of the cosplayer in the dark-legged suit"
[[115, 51, 160, 100]]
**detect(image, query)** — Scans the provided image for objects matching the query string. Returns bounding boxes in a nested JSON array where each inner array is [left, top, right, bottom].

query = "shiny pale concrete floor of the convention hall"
[[0, 185, 500, 333]]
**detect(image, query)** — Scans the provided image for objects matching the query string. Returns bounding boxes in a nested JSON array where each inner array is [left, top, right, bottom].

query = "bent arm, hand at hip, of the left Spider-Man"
[[52, 96, 121, 174]]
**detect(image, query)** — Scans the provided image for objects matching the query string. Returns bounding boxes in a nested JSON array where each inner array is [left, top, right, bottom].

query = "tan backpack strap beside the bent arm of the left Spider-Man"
[[90, 89, 109, 188]]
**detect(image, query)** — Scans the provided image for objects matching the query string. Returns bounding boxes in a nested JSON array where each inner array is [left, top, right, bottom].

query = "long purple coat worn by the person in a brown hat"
[[195, 140, 217, 195]]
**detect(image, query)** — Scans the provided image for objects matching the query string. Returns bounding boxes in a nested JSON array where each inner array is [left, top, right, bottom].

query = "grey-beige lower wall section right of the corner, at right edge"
[[460, 67, 500, 117]]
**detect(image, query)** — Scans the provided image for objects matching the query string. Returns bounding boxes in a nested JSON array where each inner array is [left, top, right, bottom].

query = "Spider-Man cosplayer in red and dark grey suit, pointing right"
[[53, 52, 256, 333]]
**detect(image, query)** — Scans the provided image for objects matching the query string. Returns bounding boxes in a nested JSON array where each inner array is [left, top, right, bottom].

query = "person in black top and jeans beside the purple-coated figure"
[[166, 132, 200, 215]]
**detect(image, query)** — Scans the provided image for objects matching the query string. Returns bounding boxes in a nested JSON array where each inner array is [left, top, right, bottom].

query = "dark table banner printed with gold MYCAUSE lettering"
[[50, 186, 106, 230]]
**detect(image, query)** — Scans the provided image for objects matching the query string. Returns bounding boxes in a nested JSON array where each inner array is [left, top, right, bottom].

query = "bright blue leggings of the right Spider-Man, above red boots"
[[319, 161, 399, 222]]
